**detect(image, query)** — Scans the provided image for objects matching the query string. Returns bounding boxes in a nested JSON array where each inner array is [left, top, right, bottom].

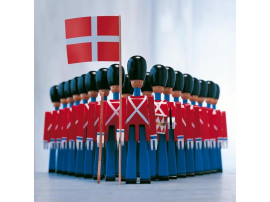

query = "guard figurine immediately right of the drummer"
[[163, 66, 177, 179]]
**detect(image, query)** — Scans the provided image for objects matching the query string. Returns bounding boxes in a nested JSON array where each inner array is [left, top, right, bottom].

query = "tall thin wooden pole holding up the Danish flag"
[[118, 15, 122, 185]]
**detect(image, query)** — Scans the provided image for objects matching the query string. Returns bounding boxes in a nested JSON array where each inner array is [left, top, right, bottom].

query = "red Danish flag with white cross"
[[65, 16, 119, 64]]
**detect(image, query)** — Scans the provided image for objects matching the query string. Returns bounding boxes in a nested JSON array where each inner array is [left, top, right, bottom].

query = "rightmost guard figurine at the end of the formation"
[[212, 84, 223, 172]]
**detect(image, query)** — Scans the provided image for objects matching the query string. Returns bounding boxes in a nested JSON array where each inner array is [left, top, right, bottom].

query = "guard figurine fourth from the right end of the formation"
[[189, 77, 203, 175]]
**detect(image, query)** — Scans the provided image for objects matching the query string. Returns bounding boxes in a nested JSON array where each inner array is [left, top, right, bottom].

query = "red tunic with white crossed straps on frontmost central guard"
[[125, 96, 156, 141]]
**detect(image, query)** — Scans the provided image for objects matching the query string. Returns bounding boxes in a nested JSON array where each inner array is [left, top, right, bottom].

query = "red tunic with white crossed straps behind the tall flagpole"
[[104, 98, 127, 142]]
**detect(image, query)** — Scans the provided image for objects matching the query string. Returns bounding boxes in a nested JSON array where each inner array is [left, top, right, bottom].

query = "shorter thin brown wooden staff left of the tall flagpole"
[[97, 92, 104, 184]]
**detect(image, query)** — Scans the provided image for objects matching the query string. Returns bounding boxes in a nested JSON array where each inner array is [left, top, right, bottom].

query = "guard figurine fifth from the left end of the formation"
[[74, 74, 89, 177]]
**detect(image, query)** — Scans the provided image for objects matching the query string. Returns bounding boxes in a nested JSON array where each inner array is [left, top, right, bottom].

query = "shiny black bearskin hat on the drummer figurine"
[[150, 64, 168, 87]]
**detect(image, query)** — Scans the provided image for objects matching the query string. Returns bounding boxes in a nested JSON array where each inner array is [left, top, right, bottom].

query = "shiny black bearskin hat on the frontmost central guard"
[[127, 55, 147, 81]]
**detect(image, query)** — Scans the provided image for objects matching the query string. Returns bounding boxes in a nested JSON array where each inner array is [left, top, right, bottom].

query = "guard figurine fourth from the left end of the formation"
[[68, 77, 81, 175]]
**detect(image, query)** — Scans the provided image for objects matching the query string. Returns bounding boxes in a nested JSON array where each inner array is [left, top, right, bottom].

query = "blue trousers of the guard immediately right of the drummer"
[[168, 129, 177, 179]]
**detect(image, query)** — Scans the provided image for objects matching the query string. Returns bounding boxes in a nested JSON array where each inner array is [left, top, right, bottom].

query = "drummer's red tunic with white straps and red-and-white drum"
[[155, 100, 170, 141]]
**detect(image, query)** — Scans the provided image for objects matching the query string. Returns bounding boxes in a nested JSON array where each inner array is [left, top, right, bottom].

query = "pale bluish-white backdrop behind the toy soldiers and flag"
[[34, 0, 236, 172]]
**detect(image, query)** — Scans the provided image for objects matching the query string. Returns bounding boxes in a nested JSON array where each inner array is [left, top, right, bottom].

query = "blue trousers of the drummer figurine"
[[157, 134, 169, 180]]
